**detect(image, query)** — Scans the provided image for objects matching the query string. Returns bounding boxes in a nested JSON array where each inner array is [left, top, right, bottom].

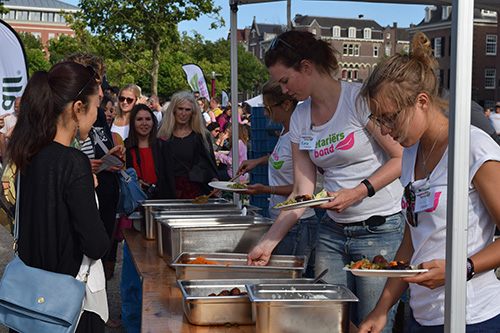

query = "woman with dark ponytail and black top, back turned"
[[8, 62, 109, 332]]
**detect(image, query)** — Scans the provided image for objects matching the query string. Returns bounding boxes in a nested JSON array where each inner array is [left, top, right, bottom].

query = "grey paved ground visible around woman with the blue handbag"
[[0, 227, 125, 333]]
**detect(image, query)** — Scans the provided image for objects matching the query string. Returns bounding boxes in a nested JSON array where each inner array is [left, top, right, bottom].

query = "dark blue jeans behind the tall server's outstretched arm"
[[273, 215, 319, 278]]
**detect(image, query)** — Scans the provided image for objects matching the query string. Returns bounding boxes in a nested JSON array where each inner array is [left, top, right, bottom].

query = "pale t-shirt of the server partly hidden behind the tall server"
[[267, 132, 315, 219]]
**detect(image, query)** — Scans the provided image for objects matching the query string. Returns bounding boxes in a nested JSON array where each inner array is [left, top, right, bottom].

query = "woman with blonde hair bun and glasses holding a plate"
[[359, 33, 500, 333]]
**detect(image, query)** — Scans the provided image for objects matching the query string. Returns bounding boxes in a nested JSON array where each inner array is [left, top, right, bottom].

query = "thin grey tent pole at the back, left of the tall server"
[[229, 0, 240, 203]]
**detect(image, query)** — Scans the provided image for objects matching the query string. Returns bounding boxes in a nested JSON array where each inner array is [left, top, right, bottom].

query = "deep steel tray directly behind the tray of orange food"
[[157, 216, 273, 265]]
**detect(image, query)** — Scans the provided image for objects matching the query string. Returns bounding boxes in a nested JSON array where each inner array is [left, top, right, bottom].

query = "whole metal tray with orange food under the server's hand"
[[171, 252, 307, 280]]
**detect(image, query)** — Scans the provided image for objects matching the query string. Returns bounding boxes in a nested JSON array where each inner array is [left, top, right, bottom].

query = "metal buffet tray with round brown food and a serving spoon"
[[177, 279, 322, 325]]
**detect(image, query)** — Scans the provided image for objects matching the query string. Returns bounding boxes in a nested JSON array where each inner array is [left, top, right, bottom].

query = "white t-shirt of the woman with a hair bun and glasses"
[[401, 126, 500, 326]]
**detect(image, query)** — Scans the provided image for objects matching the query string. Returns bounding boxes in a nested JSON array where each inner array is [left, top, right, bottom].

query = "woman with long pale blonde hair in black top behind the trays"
[[158, 91, 217, 199]]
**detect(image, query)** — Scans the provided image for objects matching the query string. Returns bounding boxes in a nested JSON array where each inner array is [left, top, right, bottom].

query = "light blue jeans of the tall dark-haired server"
[[315, 213, 405, 332]]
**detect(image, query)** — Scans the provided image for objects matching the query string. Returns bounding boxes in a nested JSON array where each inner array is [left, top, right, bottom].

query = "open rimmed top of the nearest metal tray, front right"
[[246, 283, 359, 302]]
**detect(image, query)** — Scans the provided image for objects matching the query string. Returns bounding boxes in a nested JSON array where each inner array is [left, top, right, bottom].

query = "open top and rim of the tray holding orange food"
[[170, 252, 307, 272]]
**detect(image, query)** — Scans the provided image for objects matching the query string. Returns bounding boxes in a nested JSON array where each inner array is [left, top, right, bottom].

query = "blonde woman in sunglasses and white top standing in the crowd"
[[111, 84, 141, 143]]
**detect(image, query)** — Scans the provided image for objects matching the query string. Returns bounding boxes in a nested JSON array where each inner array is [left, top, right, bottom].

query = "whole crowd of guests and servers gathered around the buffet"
[[0, 31, 500, 332]]
